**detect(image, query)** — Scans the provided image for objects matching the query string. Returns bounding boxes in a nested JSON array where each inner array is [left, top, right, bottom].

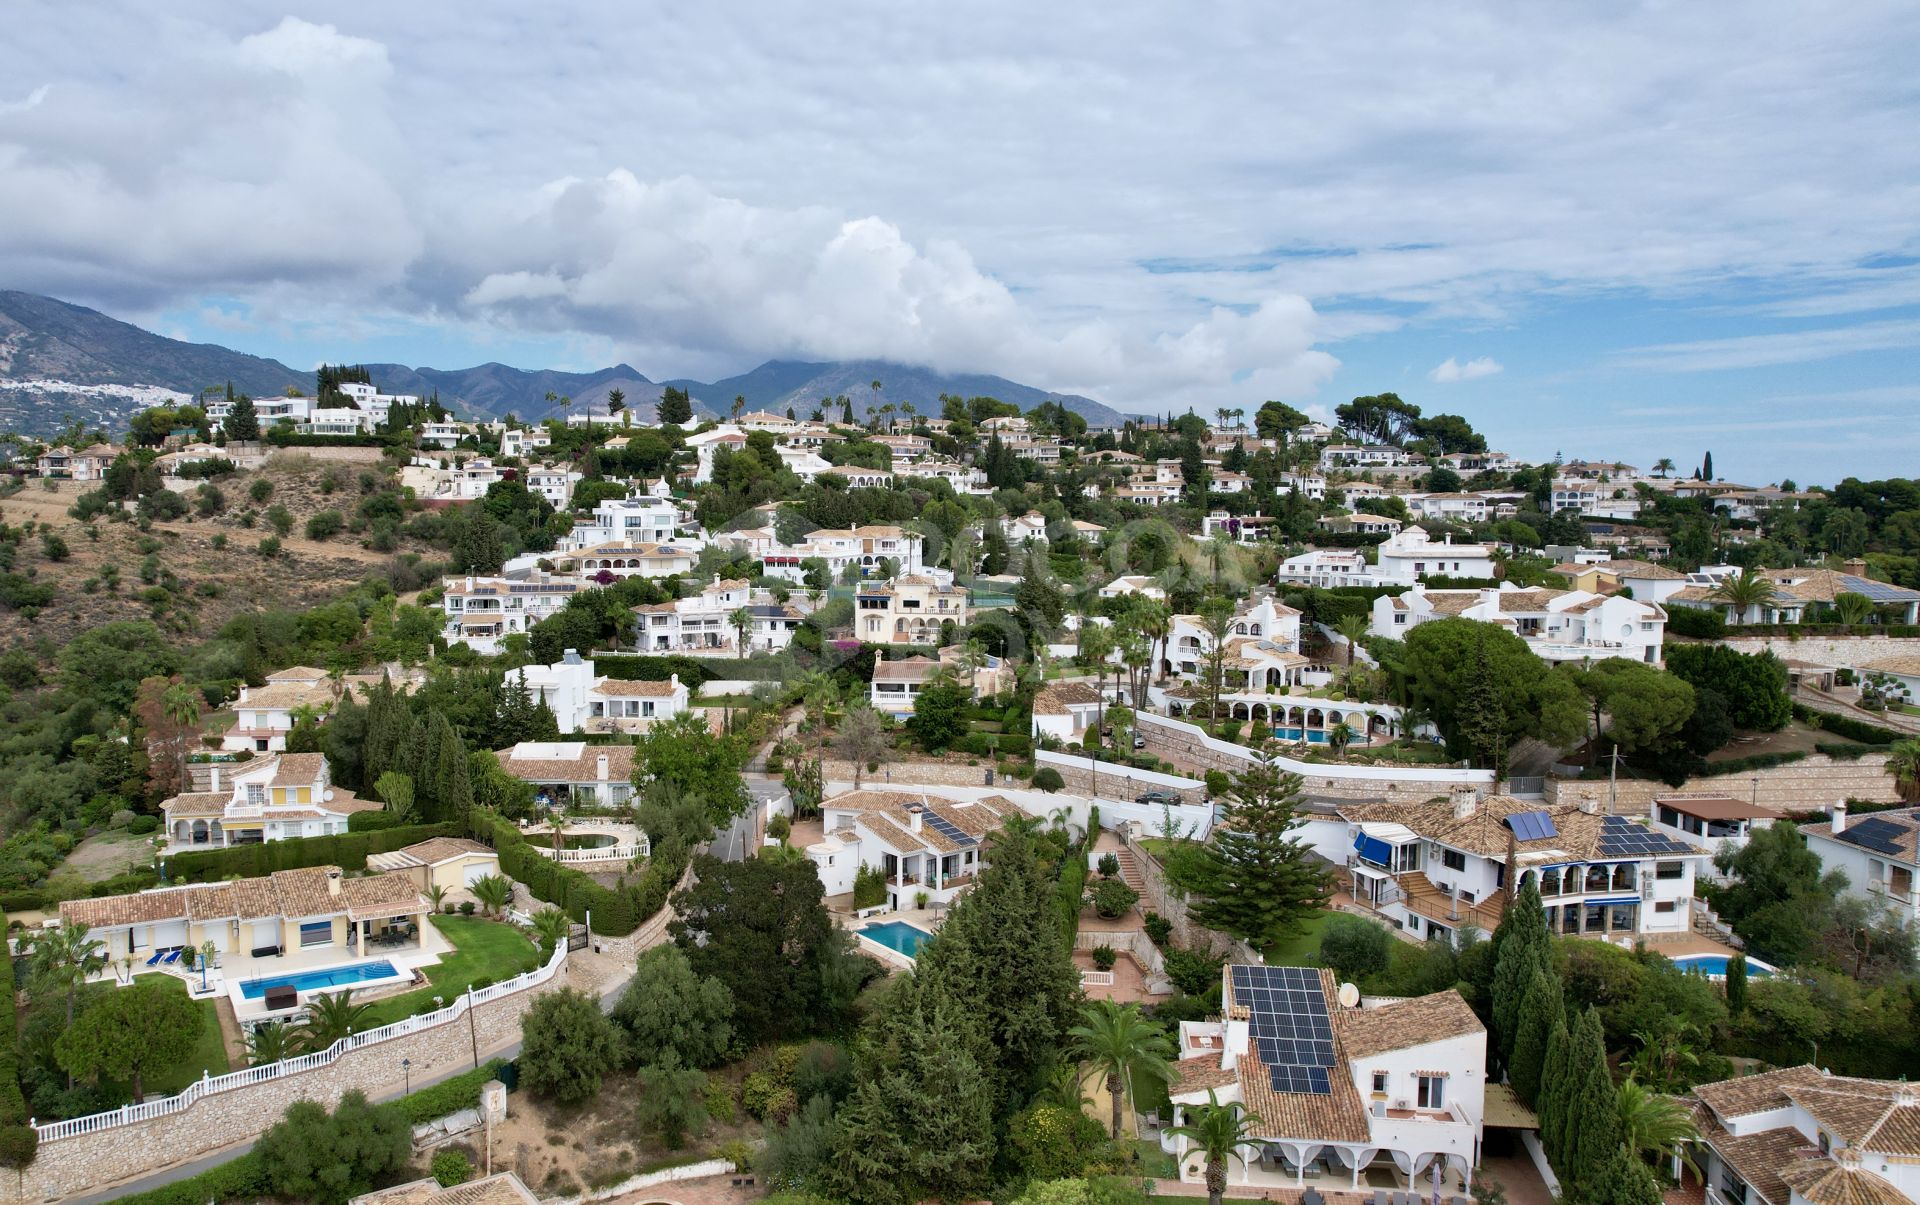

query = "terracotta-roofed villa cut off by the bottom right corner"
[[1684, 1065, 1920, 1205]]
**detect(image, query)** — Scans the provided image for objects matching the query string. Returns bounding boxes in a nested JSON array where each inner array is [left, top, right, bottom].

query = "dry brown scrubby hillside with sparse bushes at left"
[[0, 449, 447, 645]]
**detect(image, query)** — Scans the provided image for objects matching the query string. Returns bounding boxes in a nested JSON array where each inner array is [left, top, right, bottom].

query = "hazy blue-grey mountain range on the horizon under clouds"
[[0, 290, 1123, 436]]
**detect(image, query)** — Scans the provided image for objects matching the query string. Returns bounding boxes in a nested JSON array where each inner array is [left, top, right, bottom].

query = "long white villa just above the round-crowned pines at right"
[[1371, 581, 1667, 666]]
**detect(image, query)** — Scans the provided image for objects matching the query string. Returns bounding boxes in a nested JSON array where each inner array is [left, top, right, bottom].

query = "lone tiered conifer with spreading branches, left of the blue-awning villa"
[[1181, 741, 1332, 946]]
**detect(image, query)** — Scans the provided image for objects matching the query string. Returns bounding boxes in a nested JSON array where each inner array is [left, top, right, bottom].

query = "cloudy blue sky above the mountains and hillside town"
[[0, 0, 1920, 484]]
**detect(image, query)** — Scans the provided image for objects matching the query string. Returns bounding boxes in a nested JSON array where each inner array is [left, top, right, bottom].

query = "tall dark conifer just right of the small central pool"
[[914, 835, 1079, 1113]]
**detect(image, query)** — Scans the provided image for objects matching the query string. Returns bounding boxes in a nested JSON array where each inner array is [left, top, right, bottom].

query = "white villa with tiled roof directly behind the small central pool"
[[806, 791, 1021, 910]]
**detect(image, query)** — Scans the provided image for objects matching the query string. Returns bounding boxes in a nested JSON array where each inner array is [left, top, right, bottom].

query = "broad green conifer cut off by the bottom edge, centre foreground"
[[828, 978, 995, 1205]]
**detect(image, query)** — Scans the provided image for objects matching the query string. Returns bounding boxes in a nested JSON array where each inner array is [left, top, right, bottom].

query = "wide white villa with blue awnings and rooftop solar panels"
[[1302, 789, 1705, 942]]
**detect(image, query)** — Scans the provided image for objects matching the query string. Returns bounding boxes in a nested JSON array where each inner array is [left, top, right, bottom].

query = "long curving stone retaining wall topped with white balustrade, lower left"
[[13, 969, 566, 1205]]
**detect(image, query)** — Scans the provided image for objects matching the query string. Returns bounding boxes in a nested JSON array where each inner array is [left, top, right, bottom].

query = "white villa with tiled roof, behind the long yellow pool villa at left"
[[159, 754, 382, 852]]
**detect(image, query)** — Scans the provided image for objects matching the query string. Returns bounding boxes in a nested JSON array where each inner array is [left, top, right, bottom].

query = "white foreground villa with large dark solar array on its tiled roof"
[[1160, 963, 1488, 1199]]
